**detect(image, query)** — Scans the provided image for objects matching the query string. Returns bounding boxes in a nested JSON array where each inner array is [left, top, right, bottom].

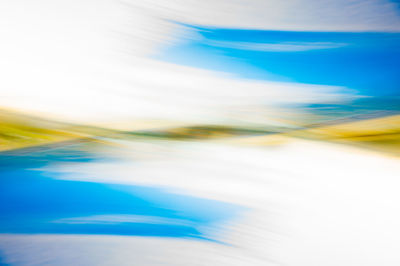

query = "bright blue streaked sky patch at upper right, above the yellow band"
[[156, 26, 400, 96]]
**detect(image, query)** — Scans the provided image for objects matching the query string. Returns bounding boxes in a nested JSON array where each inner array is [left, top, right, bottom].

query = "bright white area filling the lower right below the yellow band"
[[14, 138, 400, 266]]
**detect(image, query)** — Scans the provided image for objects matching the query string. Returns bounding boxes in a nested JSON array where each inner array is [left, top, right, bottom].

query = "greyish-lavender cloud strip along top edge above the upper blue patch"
[[122, 0, 400, 32]]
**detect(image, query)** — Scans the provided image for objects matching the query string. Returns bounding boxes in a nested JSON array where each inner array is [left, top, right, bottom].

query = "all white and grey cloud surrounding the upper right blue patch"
[[0, 0, 378, 127]]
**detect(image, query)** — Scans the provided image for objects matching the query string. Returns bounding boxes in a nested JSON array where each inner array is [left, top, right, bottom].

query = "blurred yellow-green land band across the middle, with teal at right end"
[[0, 94, 400, 156]]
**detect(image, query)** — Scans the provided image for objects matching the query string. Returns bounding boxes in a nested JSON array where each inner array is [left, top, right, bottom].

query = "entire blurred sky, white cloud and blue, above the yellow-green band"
[[0, 0, 400, 122]]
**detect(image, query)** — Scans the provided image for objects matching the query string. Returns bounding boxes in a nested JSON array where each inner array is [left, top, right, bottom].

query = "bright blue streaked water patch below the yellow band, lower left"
[[0, 144, 241, 239]]
